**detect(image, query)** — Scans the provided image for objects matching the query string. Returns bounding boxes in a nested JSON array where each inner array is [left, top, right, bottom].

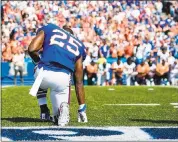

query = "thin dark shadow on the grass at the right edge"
[[129, 119, 178, 124]]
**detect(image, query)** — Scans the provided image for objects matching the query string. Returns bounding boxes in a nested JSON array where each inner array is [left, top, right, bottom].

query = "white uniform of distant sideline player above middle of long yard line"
[[124, 62, 137, 86]]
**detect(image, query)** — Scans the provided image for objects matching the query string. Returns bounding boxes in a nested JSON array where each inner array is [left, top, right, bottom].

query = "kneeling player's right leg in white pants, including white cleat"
[[49, 72, 71, 126]]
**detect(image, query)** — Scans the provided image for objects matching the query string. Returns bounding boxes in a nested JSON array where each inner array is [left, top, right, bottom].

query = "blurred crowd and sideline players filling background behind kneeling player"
[[1, 0, 178, 86]]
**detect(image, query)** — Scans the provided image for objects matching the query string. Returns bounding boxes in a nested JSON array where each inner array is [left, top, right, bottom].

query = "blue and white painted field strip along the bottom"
[[2, 127, 178, 141]]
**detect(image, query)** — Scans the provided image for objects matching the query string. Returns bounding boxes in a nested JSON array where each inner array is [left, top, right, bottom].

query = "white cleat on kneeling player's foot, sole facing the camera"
[[57, 102, 70, 126]]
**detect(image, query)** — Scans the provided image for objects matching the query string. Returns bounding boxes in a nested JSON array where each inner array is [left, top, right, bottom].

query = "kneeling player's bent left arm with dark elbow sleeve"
[[28, 30, 45, 64]]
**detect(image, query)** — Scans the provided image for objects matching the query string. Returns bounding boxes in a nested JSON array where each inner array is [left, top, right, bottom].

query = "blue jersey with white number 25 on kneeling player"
[[37, 23, 86, 72]]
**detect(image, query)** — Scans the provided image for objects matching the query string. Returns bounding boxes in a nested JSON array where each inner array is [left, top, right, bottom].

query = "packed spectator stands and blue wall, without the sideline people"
[[1, 0, 178, 85]]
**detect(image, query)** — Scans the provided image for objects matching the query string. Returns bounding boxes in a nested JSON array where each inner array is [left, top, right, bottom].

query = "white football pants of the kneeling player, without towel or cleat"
[[34, 68, 71, 116]]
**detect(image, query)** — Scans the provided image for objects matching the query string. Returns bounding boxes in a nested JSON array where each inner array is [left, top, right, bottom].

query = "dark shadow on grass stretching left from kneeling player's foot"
[[1, 117, 50, 122]]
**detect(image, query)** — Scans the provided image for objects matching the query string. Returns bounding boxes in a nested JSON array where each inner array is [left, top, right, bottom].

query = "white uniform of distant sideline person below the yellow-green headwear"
[[97, 63, 111, 86]]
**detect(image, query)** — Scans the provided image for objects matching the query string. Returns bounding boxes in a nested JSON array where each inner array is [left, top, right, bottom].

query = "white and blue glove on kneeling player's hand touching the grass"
[[78, 104, 88, 123]]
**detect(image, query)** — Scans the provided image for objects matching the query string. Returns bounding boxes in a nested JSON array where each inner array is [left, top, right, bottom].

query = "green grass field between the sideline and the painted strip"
[[1, 86, 178, 127]]
